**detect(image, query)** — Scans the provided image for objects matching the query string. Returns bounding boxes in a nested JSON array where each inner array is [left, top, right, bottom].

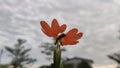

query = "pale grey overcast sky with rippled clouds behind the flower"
[[0, 0, 120, 65]]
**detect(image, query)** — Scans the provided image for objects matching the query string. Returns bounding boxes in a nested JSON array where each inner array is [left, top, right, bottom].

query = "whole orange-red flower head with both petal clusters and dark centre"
[[40, 19, 83, 45]]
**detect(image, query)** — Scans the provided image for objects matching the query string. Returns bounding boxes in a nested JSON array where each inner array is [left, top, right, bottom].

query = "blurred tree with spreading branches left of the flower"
[[5, 39, 36, 68]]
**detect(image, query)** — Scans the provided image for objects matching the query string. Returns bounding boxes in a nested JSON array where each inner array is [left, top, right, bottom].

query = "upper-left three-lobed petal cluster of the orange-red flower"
[[40, 19, 67, 38]]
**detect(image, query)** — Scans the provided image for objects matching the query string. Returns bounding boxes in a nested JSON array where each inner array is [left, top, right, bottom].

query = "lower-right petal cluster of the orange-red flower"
[[61, 28, 83, 45]]
